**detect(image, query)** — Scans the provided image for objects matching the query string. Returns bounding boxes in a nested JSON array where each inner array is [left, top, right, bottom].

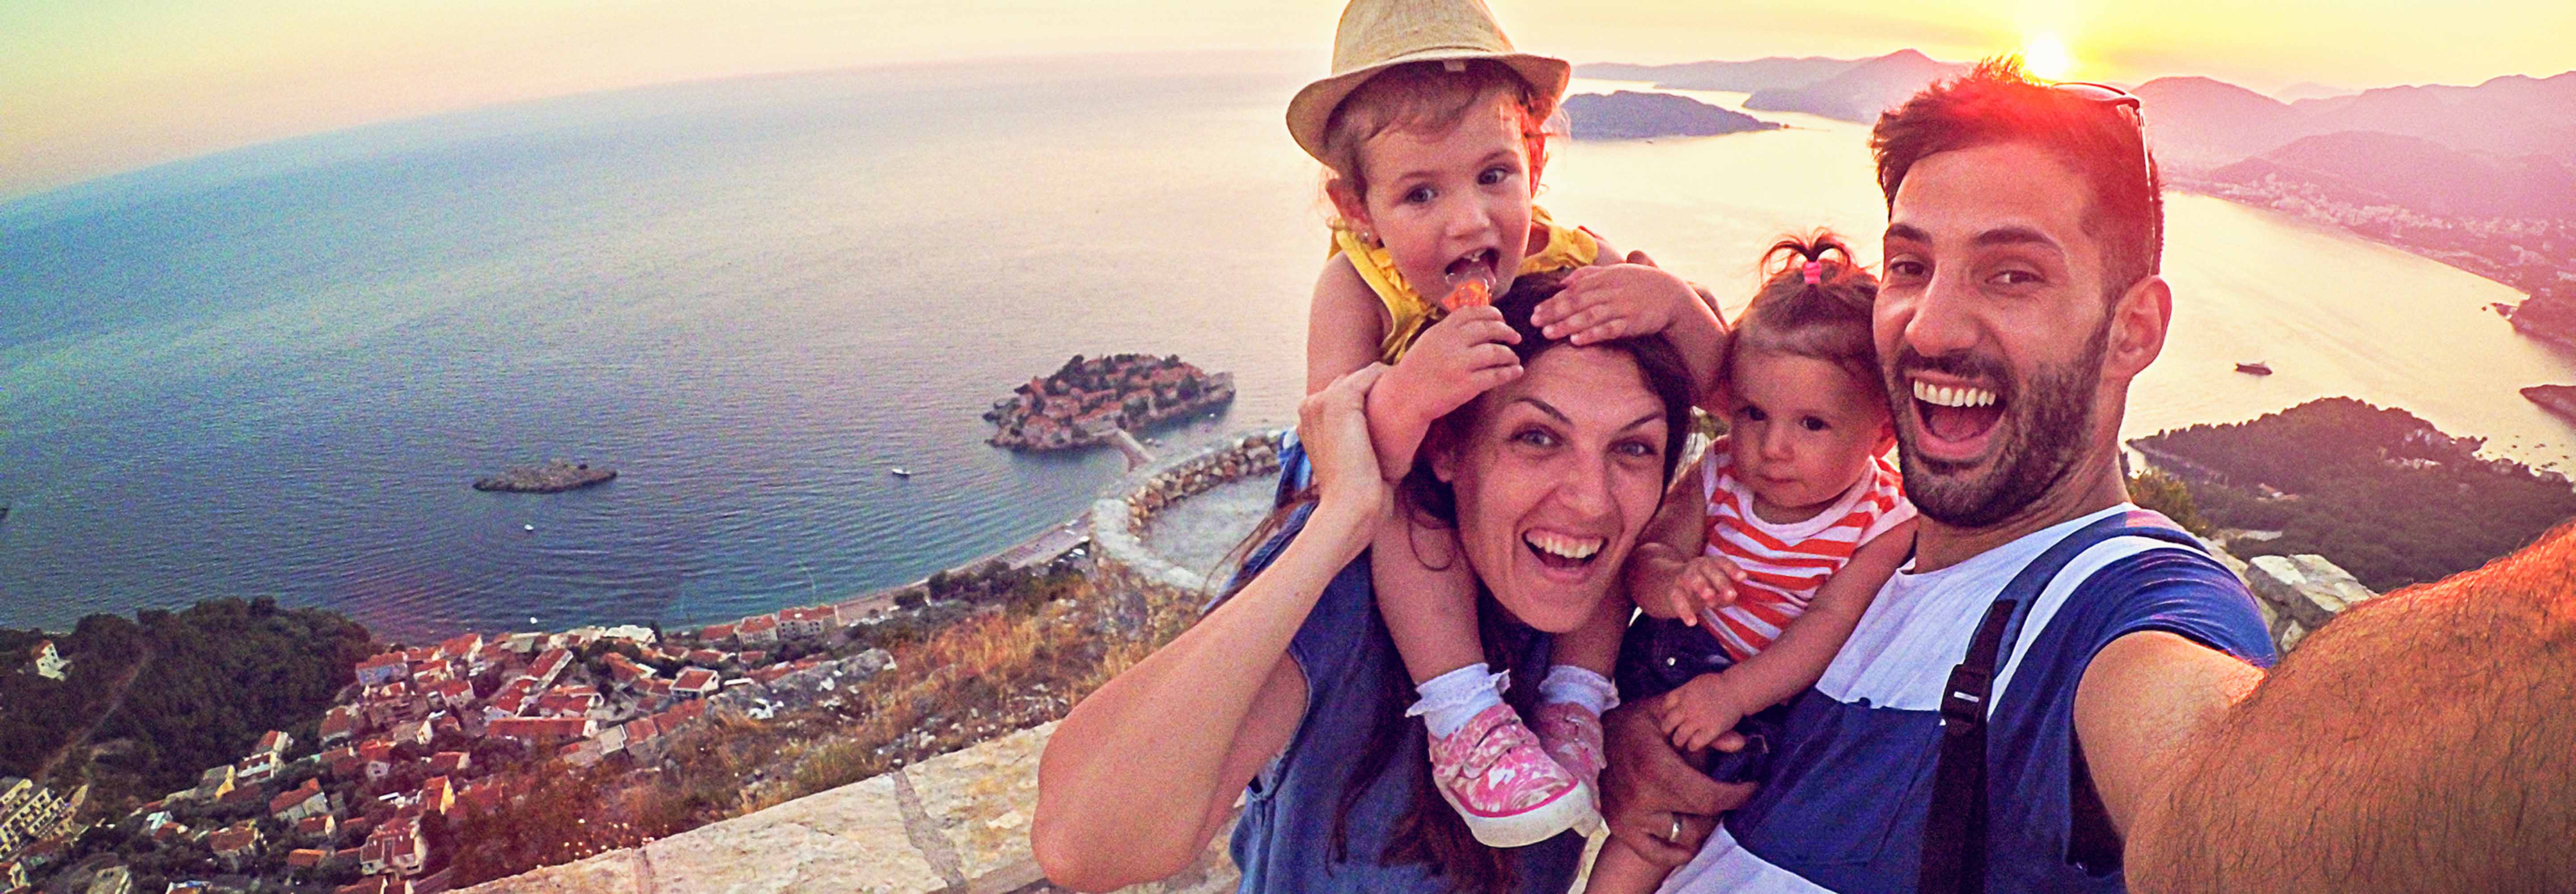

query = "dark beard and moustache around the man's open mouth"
[[1888, 320, 2110, 528]]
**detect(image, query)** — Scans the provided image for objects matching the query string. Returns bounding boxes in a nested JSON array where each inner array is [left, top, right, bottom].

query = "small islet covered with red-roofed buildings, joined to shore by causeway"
[[984, 353, 1234, 451]]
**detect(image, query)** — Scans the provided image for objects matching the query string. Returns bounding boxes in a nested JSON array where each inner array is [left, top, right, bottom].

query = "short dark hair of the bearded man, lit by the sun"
[[1870, 57, 2164, 299]]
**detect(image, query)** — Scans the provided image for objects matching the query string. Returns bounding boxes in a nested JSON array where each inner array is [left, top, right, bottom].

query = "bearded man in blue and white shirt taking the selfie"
[[1605, 62, 2576, 891]]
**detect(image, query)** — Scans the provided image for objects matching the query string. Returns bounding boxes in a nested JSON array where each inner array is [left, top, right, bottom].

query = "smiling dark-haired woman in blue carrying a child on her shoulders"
[[1033, 278, 1692, 894]]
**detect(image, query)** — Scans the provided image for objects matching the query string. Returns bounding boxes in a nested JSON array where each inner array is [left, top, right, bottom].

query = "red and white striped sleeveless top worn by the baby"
[[1700, 438, 1914, 662]]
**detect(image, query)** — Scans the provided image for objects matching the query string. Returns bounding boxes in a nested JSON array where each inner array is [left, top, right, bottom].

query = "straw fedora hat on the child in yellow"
[[1288, 0, 1574, 160]]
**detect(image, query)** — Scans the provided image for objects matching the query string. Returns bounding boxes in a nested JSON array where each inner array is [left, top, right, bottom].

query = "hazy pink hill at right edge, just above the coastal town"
[[2207, 131, 2576, 219]]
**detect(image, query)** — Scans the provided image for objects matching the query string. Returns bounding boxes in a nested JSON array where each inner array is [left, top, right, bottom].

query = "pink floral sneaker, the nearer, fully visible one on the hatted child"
[[1432, 706, 1600, 848]]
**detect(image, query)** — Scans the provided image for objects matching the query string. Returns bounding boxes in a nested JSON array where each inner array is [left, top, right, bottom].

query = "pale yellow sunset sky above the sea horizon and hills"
[[0, 0, 2576, 198]]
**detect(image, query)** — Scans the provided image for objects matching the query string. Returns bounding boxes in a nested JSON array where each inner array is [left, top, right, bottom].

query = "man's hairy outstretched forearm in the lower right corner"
[[2128, 526, 2576, 891]]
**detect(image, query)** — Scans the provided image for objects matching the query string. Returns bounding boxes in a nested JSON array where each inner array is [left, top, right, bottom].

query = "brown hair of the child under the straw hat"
[[1324, 59, 1556, 214]]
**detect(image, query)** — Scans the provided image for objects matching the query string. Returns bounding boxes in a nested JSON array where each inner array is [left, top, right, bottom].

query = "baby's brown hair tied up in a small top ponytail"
[[1718, 229, 1885, 402]]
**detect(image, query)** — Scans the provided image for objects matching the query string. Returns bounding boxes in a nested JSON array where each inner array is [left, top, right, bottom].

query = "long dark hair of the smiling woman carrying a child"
[[1218, 273, 1698, 894]]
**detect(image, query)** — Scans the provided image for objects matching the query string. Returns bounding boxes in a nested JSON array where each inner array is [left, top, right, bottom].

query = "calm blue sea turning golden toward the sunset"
[[0, 54, 2576, 641]]
